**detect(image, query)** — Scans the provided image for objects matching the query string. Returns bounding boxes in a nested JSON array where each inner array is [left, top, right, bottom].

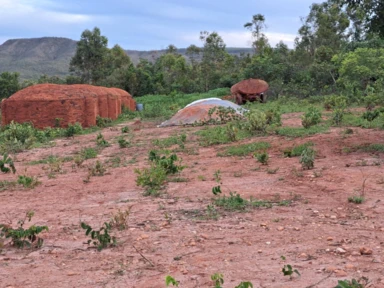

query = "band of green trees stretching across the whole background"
[[0, 0, 384, 98]]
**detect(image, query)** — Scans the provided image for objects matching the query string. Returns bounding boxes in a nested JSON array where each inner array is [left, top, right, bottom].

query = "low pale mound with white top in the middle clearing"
[[159, 98, 247, 127]]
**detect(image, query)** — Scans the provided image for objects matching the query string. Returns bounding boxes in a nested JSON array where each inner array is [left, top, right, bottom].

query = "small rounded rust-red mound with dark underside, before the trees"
[[231, 78, 269, 105]]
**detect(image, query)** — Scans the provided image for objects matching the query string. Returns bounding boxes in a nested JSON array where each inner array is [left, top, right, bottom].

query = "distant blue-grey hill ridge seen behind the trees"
[[0, 37, 252, 80]]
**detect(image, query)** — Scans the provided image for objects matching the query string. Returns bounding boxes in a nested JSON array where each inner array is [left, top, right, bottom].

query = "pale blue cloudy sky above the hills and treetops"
[[0, 0, 322, 50]]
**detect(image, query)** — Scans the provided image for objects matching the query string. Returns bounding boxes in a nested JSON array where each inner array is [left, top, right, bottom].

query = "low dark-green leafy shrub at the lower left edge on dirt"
[[0, 211, 48, 248]]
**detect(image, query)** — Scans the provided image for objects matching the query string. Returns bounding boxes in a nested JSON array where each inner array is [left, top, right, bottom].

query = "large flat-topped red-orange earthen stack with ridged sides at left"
[[1, 84, 136, 128]]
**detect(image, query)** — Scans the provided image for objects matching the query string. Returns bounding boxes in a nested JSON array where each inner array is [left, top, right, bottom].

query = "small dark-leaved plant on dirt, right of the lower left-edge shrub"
[[81, 222, 116, 251]]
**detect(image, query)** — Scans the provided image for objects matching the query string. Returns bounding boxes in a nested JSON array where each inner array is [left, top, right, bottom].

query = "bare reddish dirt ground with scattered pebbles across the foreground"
[[0, 113, 384, 288]]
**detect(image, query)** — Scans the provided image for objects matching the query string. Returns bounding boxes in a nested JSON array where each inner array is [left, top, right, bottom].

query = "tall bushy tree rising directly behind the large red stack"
[[69, 27, 108, 84]]
